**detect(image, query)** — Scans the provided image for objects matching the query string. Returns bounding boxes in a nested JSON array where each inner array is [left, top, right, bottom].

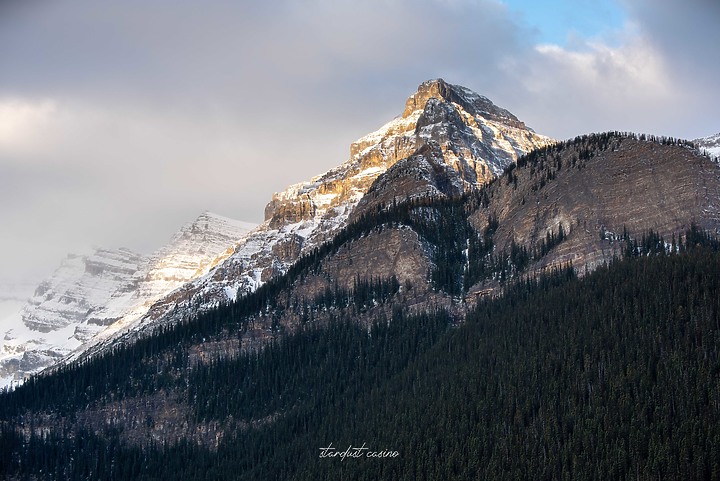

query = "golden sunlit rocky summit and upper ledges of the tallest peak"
[[265, 79, 553, 229]]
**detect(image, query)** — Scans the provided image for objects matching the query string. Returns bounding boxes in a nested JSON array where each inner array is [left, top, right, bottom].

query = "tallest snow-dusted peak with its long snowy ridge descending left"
[[71, 79, 554, 359]]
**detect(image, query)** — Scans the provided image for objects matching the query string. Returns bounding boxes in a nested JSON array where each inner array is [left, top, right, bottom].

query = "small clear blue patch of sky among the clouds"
[[501, 0, 627, 46]]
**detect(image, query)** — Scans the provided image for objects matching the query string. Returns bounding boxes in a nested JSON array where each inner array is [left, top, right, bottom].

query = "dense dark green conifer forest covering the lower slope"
[[0, 237, 720, 480]]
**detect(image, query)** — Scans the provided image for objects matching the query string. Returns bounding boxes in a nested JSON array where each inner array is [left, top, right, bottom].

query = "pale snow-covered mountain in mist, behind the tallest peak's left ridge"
[[0, 212, 255, 387]]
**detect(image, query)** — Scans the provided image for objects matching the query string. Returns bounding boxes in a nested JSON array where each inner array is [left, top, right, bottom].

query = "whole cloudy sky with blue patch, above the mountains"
[[0, 0, 720, 282]]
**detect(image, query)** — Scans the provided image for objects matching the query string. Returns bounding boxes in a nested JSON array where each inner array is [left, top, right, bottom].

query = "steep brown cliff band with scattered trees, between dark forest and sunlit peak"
[[268, 133, 720, 316]]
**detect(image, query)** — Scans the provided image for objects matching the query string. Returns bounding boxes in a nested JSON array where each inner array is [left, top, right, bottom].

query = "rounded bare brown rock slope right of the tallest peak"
[[471, 134, 720, 284]]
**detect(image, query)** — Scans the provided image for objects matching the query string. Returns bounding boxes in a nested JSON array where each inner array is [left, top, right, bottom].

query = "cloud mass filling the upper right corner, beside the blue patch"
[[496, 0, 720, 138]]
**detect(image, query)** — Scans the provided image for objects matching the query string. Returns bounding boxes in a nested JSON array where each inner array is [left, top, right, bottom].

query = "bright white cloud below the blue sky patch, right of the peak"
[[492, 22, 718, 138]]
